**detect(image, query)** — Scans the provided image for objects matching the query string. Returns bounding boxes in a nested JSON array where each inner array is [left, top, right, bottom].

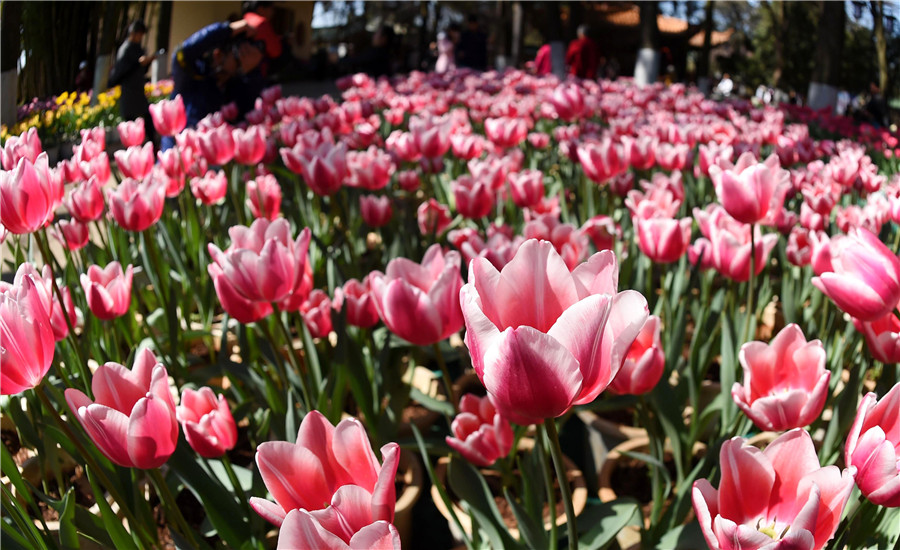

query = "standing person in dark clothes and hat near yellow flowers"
[[109, 19, 156, 146]]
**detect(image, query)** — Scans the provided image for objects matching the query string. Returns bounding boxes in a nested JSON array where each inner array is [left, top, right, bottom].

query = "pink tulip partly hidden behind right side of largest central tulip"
[[609, 315, 666, 395]]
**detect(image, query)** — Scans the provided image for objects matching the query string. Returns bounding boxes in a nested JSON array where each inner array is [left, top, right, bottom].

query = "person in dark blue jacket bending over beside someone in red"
[[162, 19, 263, 150]]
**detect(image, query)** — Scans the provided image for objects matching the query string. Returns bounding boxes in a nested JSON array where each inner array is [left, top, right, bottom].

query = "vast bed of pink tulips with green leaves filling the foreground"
[[0, 71, 900, 548]]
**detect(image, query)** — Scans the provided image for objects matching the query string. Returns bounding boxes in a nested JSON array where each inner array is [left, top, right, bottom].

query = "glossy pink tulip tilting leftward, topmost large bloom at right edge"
[[812, 229, 900, 321]]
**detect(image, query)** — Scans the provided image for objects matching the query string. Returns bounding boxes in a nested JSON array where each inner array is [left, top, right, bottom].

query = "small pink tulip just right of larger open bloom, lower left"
[[175, 386, 237, 458]]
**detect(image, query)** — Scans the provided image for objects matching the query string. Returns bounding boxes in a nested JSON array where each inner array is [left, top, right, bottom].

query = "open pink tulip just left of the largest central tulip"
[[369, 244, 463, 346]]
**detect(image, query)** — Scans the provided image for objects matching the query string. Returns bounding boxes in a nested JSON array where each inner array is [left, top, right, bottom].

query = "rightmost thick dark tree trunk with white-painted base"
[[808, 1, 847, 109]]
